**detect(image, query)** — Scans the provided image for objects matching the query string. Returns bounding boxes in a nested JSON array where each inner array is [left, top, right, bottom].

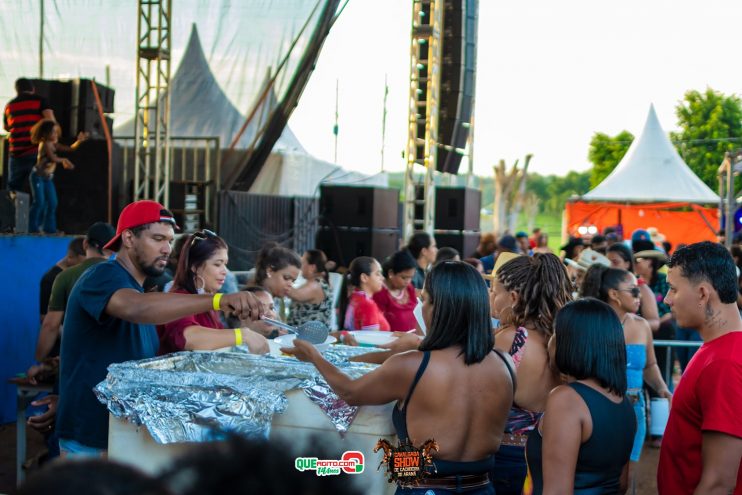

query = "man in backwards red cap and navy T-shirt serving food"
[[57, 200, 264, 456]]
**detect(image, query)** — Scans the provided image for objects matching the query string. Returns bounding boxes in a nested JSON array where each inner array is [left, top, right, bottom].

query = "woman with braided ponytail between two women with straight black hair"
[[490, 253, 572, 495]]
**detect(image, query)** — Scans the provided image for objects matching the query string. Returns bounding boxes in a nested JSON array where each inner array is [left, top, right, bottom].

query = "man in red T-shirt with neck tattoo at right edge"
[[657, 242, 742, 495]]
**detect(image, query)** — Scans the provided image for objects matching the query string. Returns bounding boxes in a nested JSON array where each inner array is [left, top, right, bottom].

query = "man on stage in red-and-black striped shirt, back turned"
[[3, 78, 55, 191]]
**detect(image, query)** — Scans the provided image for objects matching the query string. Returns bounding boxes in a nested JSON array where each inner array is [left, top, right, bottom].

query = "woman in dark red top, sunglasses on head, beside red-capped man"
[[157, 230, 268, 355]]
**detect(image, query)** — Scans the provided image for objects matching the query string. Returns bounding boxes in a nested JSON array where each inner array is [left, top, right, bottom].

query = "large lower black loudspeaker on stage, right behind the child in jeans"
[[54, 140, 121, 234]]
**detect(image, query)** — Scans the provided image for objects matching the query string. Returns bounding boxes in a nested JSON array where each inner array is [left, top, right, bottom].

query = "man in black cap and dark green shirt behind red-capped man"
[[36, 222, 116, 361]]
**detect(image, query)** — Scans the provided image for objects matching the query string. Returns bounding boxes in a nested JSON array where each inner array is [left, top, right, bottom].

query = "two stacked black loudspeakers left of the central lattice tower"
[[316, 186, 399, 267]]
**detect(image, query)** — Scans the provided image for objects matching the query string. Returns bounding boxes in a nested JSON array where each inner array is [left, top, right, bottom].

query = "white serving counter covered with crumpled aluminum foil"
[[101, 345, 402, 493]]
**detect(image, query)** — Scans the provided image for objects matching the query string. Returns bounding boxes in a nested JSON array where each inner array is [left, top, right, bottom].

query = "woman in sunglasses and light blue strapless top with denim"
[[580, 265, 672, 488]]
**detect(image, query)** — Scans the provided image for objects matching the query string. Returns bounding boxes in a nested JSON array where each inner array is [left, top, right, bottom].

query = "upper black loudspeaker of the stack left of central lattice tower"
[[320, 186, 399, 229]]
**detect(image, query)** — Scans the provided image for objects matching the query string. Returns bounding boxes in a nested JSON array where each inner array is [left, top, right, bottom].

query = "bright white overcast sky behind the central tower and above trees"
[[290, 0, 742, 175]]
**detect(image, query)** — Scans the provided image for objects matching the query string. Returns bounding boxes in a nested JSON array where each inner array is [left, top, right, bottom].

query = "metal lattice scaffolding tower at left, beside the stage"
[[134, 0, 172, 207]]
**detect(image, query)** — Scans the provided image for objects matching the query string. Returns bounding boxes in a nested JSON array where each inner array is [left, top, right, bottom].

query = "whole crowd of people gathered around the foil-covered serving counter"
[[16, 201, 742, 495]]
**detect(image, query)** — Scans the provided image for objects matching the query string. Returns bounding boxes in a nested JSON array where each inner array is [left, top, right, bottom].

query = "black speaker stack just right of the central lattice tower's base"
[[435, 187, 482, 259]]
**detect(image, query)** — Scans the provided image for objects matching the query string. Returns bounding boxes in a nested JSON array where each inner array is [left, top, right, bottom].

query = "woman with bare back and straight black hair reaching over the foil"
[[282, 261, 516, 495]]
